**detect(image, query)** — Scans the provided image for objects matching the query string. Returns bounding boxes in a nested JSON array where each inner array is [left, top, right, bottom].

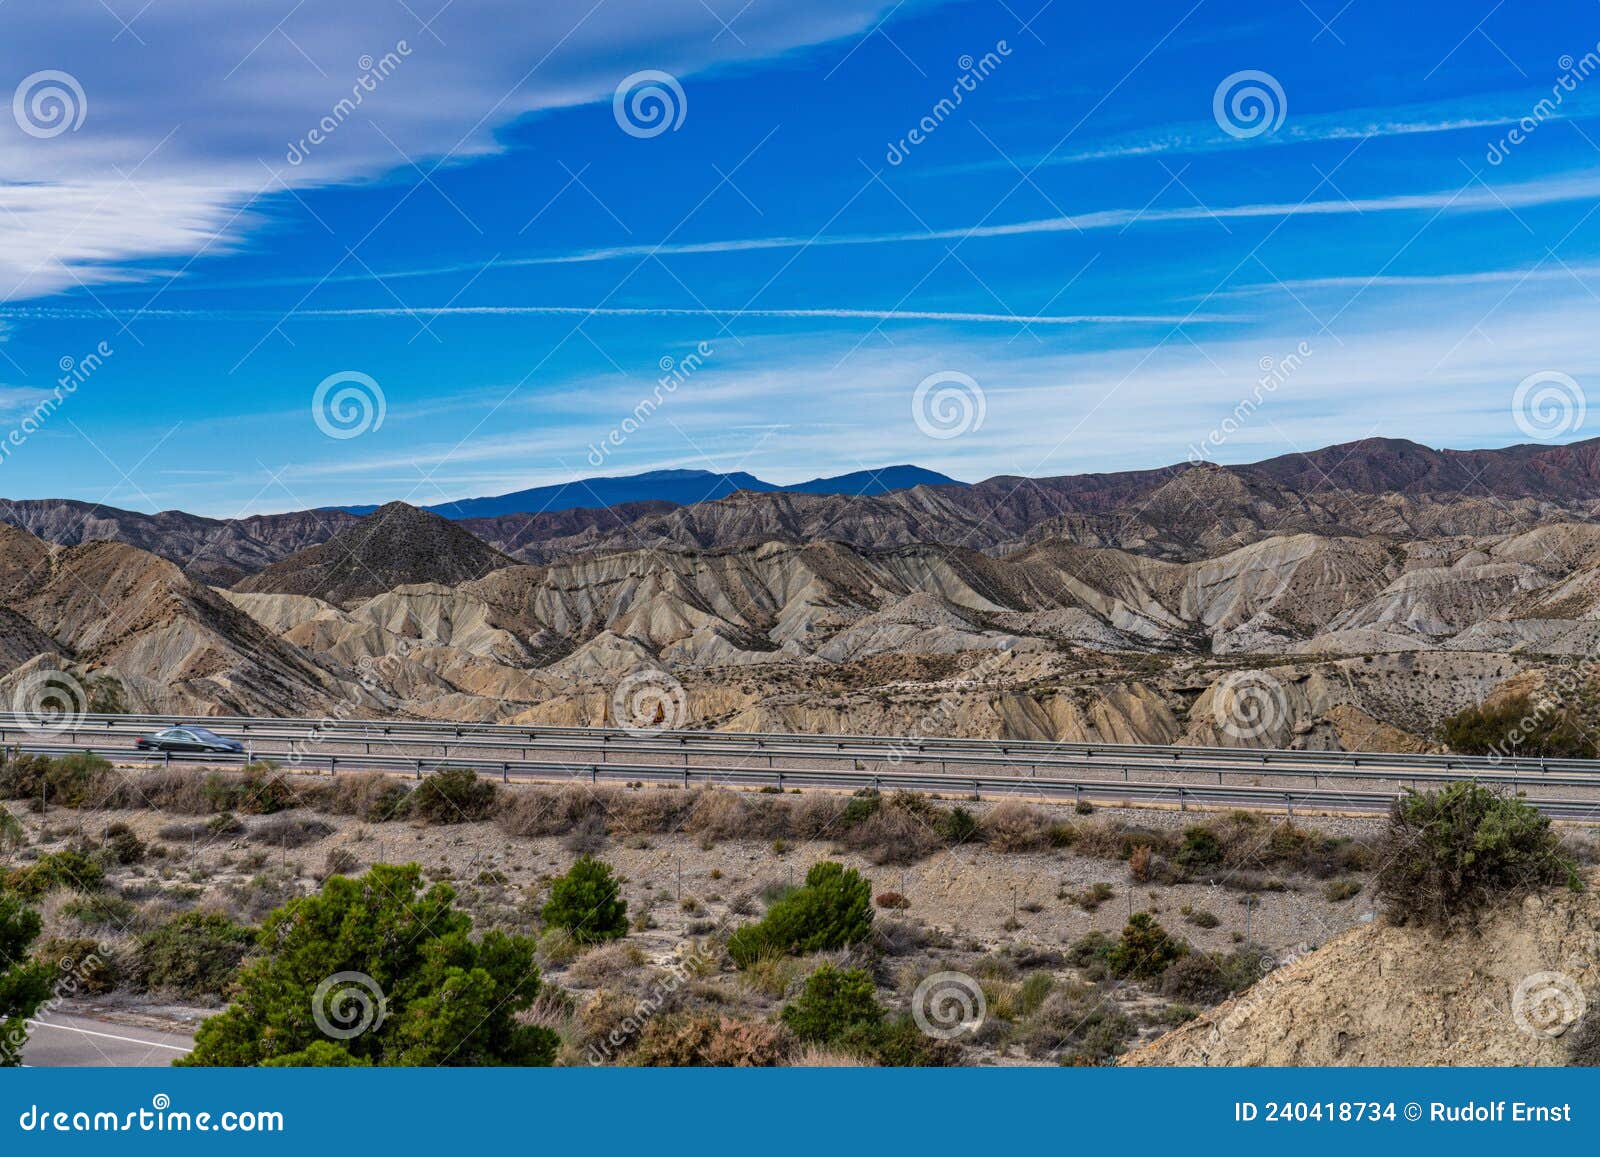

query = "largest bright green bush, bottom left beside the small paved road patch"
[[178, 864, 558, 1067]]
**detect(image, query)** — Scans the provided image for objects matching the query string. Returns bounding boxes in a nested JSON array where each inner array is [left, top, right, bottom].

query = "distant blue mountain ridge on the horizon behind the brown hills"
[[339, 466, 965, 518]]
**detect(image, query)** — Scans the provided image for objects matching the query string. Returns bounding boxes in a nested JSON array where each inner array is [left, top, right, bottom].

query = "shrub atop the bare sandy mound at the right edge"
[[1378, 783, 1582, 928]]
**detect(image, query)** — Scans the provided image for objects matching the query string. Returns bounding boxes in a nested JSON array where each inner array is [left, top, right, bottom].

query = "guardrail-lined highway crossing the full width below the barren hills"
[[9, 714, 1600, 819]]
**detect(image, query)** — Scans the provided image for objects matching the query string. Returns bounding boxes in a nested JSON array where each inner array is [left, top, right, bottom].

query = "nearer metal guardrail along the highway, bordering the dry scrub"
[[9, 744, 1600, 819]]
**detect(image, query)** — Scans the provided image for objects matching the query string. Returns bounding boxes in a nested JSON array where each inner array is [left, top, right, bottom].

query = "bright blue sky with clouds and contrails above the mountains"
[[0, 0, 1600, 517]]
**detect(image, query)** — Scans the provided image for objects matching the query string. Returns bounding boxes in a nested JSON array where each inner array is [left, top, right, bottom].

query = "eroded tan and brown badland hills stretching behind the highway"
[[0, 440, 1600, 751]]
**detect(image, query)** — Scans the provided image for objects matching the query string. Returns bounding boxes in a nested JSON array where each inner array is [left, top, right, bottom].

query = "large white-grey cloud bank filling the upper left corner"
[[0, 0, 888, 299]]
